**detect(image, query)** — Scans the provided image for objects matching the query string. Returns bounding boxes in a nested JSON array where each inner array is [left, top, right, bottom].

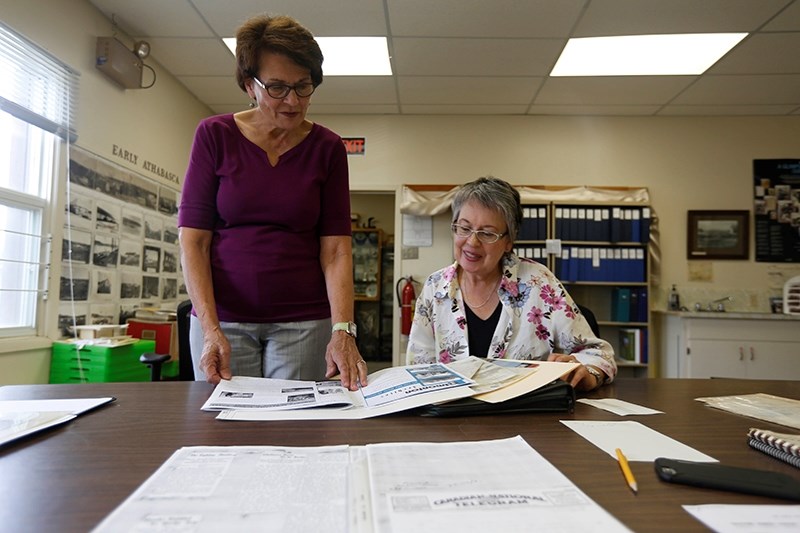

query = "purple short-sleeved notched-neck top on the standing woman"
[[178, 114, 351, 323]]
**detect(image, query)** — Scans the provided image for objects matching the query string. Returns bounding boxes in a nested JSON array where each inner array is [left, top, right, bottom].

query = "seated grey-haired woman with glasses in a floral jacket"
[[407, 177, 617, 390]]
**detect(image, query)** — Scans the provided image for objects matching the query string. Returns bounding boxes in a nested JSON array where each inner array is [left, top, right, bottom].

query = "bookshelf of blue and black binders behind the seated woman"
[[514, 191, 657, 377]]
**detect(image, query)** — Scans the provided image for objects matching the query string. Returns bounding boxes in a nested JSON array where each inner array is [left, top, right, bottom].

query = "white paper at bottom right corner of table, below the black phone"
[[683, 504, 800, 533]]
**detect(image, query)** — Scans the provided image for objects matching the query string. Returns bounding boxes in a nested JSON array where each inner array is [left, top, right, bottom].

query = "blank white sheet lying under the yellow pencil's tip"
[[561, 420, 717, 463]]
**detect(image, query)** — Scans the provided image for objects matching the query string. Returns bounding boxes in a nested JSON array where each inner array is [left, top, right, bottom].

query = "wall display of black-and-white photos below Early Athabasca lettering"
[[58, 147, 188, 335]]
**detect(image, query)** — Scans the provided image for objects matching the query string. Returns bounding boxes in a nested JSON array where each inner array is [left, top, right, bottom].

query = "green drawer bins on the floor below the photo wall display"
[[50, 340, 156, 383]]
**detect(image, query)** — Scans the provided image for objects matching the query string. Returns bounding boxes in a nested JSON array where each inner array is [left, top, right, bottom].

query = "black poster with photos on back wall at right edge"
[[753, 159, 800, 263]]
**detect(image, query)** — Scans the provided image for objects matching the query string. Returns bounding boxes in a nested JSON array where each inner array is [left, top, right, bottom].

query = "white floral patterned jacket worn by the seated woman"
[[406, 253, 617, 380]]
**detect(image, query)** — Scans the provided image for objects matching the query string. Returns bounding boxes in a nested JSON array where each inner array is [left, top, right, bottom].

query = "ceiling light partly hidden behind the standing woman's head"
[[222, 37, 392, 76]]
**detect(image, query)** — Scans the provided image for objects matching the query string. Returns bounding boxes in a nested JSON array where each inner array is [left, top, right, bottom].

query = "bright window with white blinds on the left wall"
[[0, 24, 77, 337]]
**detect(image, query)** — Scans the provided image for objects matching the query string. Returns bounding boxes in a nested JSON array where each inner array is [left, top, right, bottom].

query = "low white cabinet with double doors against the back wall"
[[661, 313, 800, 380]]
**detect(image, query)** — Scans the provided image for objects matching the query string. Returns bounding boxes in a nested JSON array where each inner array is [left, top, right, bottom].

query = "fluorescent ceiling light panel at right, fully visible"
[[550, 33, 747, 76]]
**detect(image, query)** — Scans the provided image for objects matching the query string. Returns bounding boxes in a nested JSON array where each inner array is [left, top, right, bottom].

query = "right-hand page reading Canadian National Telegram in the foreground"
[[367, 436, 629, 533]]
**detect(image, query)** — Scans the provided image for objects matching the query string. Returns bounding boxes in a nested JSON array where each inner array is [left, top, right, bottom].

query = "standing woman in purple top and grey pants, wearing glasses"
[[178, 15, 367, 390]]
